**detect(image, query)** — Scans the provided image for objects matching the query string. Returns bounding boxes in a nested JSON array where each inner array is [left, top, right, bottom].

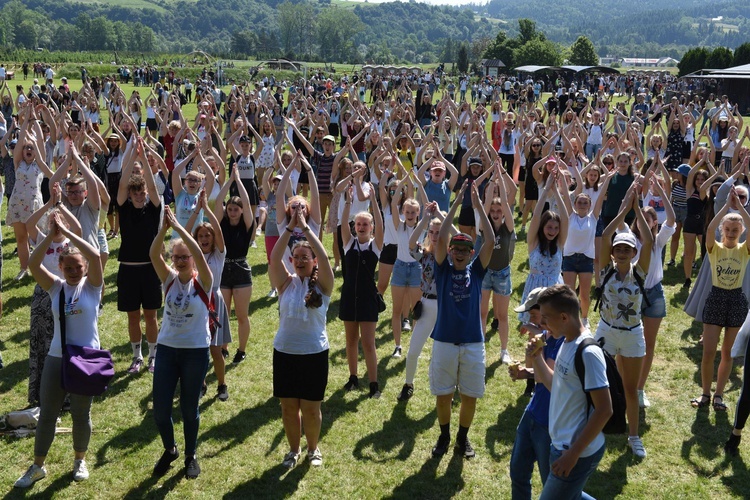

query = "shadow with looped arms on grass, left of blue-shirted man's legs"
[[354, 403, 437, 463]]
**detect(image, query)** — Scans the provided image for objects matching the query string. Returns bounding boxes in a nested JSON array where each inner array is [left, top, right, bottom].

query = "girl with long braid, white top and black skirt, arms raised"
[[269, 207, 333, 469]]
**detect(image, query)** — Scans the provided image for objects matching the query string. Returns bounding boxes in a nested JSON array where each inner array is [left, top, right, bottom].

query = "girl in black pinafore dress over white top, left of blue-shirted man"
[[339, 185, 383, 398]]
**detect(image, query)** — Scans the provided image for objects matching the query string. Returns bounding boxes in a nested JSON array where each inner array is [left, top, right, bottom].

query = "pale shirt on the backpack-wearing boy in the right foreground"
[[549, 330, 609, 457]]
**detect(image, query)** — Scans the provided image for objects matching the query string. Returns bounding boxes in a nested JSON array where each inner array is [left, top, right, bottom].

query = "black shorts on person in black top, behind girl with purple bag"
[[117, 263, 161, 312]]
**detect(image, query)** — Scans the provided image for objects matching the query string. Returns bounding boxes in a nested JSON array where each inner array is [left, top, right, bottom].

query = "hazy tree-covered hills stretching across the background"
[[0, 0, 750, 63]]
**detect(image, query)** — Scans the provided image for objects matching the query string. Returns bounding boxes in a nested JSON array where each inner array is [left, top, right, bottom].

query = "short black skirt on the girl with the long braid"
[[273, 349, 328, 401]]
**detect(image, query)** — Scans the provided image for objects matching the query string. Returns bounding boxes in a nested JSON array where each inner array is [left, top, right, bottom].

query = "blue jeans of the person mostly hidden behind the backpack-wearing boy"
[[510, 410, 550, 500]]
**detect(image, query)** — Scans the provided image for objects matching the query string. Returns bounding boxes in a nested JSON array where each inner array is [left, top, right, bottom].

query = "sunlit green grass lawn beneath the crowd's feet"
[[0, 82, 750, 499]]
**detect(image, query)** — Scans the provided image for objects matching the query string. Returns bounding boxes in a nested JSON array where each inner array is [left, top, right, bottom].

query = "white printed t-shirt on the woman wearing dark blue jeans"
[[159, 269, 211, 349]]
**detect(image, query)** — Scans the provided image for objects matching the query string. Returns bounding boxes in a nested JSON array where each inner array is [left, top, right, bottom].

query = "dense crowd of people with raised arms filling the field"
[[0, 67, 750, 498]]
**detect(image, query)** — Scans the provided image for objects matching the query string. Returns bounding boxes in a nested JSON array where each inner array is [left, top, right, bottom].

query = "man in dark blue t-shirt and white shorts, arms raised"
[[430, 183, 493, 458]]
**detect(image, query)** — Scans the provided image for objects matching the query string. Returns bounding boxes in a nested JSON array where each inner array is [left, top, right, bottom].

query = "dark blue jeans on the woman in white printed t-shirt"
[[154, 344, 208, 457]]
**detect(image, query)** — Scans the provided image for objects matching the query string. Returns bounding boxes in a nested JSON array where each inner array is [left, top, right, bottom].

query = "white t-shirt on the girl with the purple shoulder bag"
[[47, 277, 102, 358]]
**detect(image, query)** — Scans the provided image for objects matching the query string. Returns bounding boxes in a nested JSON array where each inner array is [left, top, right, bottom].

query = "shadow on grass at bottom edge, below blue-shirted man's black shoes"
[[385, 451, 466, 499]]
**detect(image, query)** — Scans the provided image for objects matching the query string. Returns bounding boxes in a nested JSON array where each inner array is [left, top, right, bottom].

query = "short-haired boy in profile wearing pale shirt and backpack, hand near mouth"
[[527, 285, 612, 500]]
